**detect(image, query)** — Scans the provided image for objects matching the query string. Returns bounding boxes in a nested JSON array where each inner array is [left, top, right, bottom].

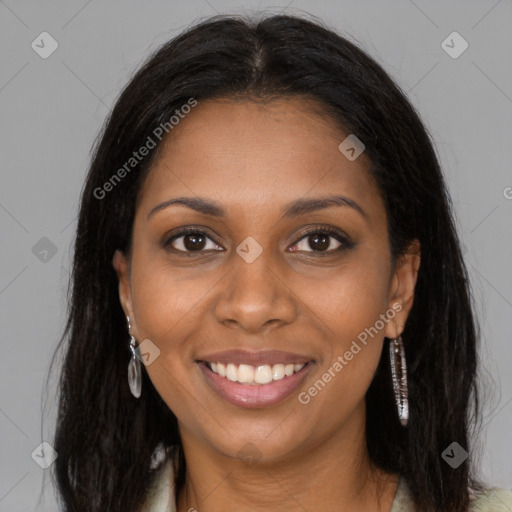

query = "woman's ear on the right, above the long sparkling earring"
[[384, 239, 421, 338]]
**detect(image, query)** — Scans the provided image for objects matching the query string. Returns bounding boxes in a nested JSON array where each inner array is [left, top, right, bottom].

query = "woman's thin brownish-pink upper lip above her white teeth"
[[197, 349, 313, 366]]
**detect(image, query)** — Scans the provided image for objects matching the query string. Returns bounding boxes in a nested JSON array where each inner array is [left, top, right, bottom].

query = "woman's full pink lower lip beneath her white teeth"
[[198, 362, 313, 408]]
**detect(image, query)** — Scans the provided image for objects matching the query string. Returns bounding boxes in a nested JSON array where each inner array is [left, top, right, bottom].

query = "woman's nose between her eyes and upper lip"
[[215, 250, 299, 333]]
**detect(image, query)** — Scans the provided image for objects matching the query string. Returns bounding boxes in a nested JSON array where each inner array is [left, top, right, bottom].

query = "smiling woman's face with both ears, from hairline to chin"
[[114, 98, 419, 461]]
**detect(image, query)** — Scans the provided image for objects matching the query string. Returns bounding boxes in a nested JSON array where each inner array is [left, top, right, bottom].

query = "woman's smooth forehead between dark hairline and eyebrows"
[[140, 98, 382, 220]]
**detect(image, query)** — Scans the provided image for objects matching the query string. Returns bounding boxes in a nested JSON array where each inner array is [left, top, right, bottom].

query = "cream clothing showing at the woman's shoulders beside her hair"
[[144, 460, 512, 512]]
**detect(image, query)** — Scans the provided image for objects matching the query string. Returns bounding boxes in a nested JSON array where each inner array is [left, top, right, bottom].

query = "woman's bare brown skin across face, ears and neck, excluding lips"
[[113, 98, 420, 512]]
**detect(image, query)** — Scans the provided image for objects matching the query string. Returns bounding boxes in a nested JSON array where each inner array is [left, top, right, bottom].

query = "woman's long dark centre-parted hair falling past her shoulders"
[[48, 15, 479, 512]]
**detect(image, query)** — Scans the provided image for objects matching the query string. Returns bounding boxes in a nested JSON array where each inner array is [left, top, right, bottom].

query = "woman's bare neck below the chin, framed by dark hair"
[[177, 408, 398, 512]]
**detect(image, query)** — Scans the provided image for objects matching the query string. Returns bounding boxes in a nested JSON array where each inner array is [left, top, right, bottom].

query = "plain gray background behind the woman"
[[0, 0, 512, 512]]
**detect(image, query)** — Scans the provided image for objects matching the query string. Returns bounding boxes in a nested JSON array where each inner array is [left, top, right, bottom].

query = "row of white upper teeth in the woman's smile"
[[208, 363, 305, 385]]
